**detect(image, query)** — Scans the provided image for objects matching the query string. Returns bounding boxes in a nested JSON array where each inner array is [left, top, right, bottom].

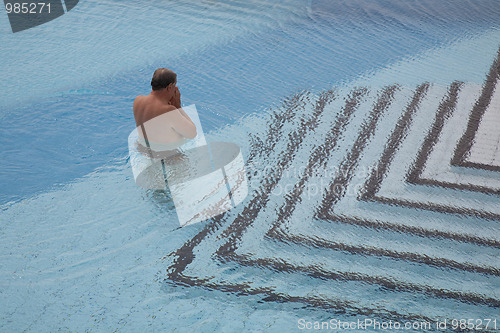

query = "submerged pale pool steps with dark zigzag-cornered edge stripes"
[[167, 51, 500, 320]]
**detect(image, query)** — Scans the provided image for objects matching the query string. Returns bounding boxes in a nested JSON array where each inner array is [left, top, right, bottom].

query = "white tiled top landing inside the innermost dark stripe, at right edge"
[[468, 79, 500, 167]]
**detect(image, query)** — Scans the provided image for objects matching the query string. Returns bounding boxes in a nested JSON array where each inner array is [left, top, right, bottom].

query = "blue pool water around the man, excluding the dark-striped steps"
[[0, 0, 500, 332]]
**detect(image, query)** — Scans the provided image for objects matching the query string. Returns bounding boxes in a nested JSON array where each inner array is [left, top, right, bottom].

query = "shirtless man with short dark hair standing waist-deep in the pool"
[[134, 68, 196, 151]]
